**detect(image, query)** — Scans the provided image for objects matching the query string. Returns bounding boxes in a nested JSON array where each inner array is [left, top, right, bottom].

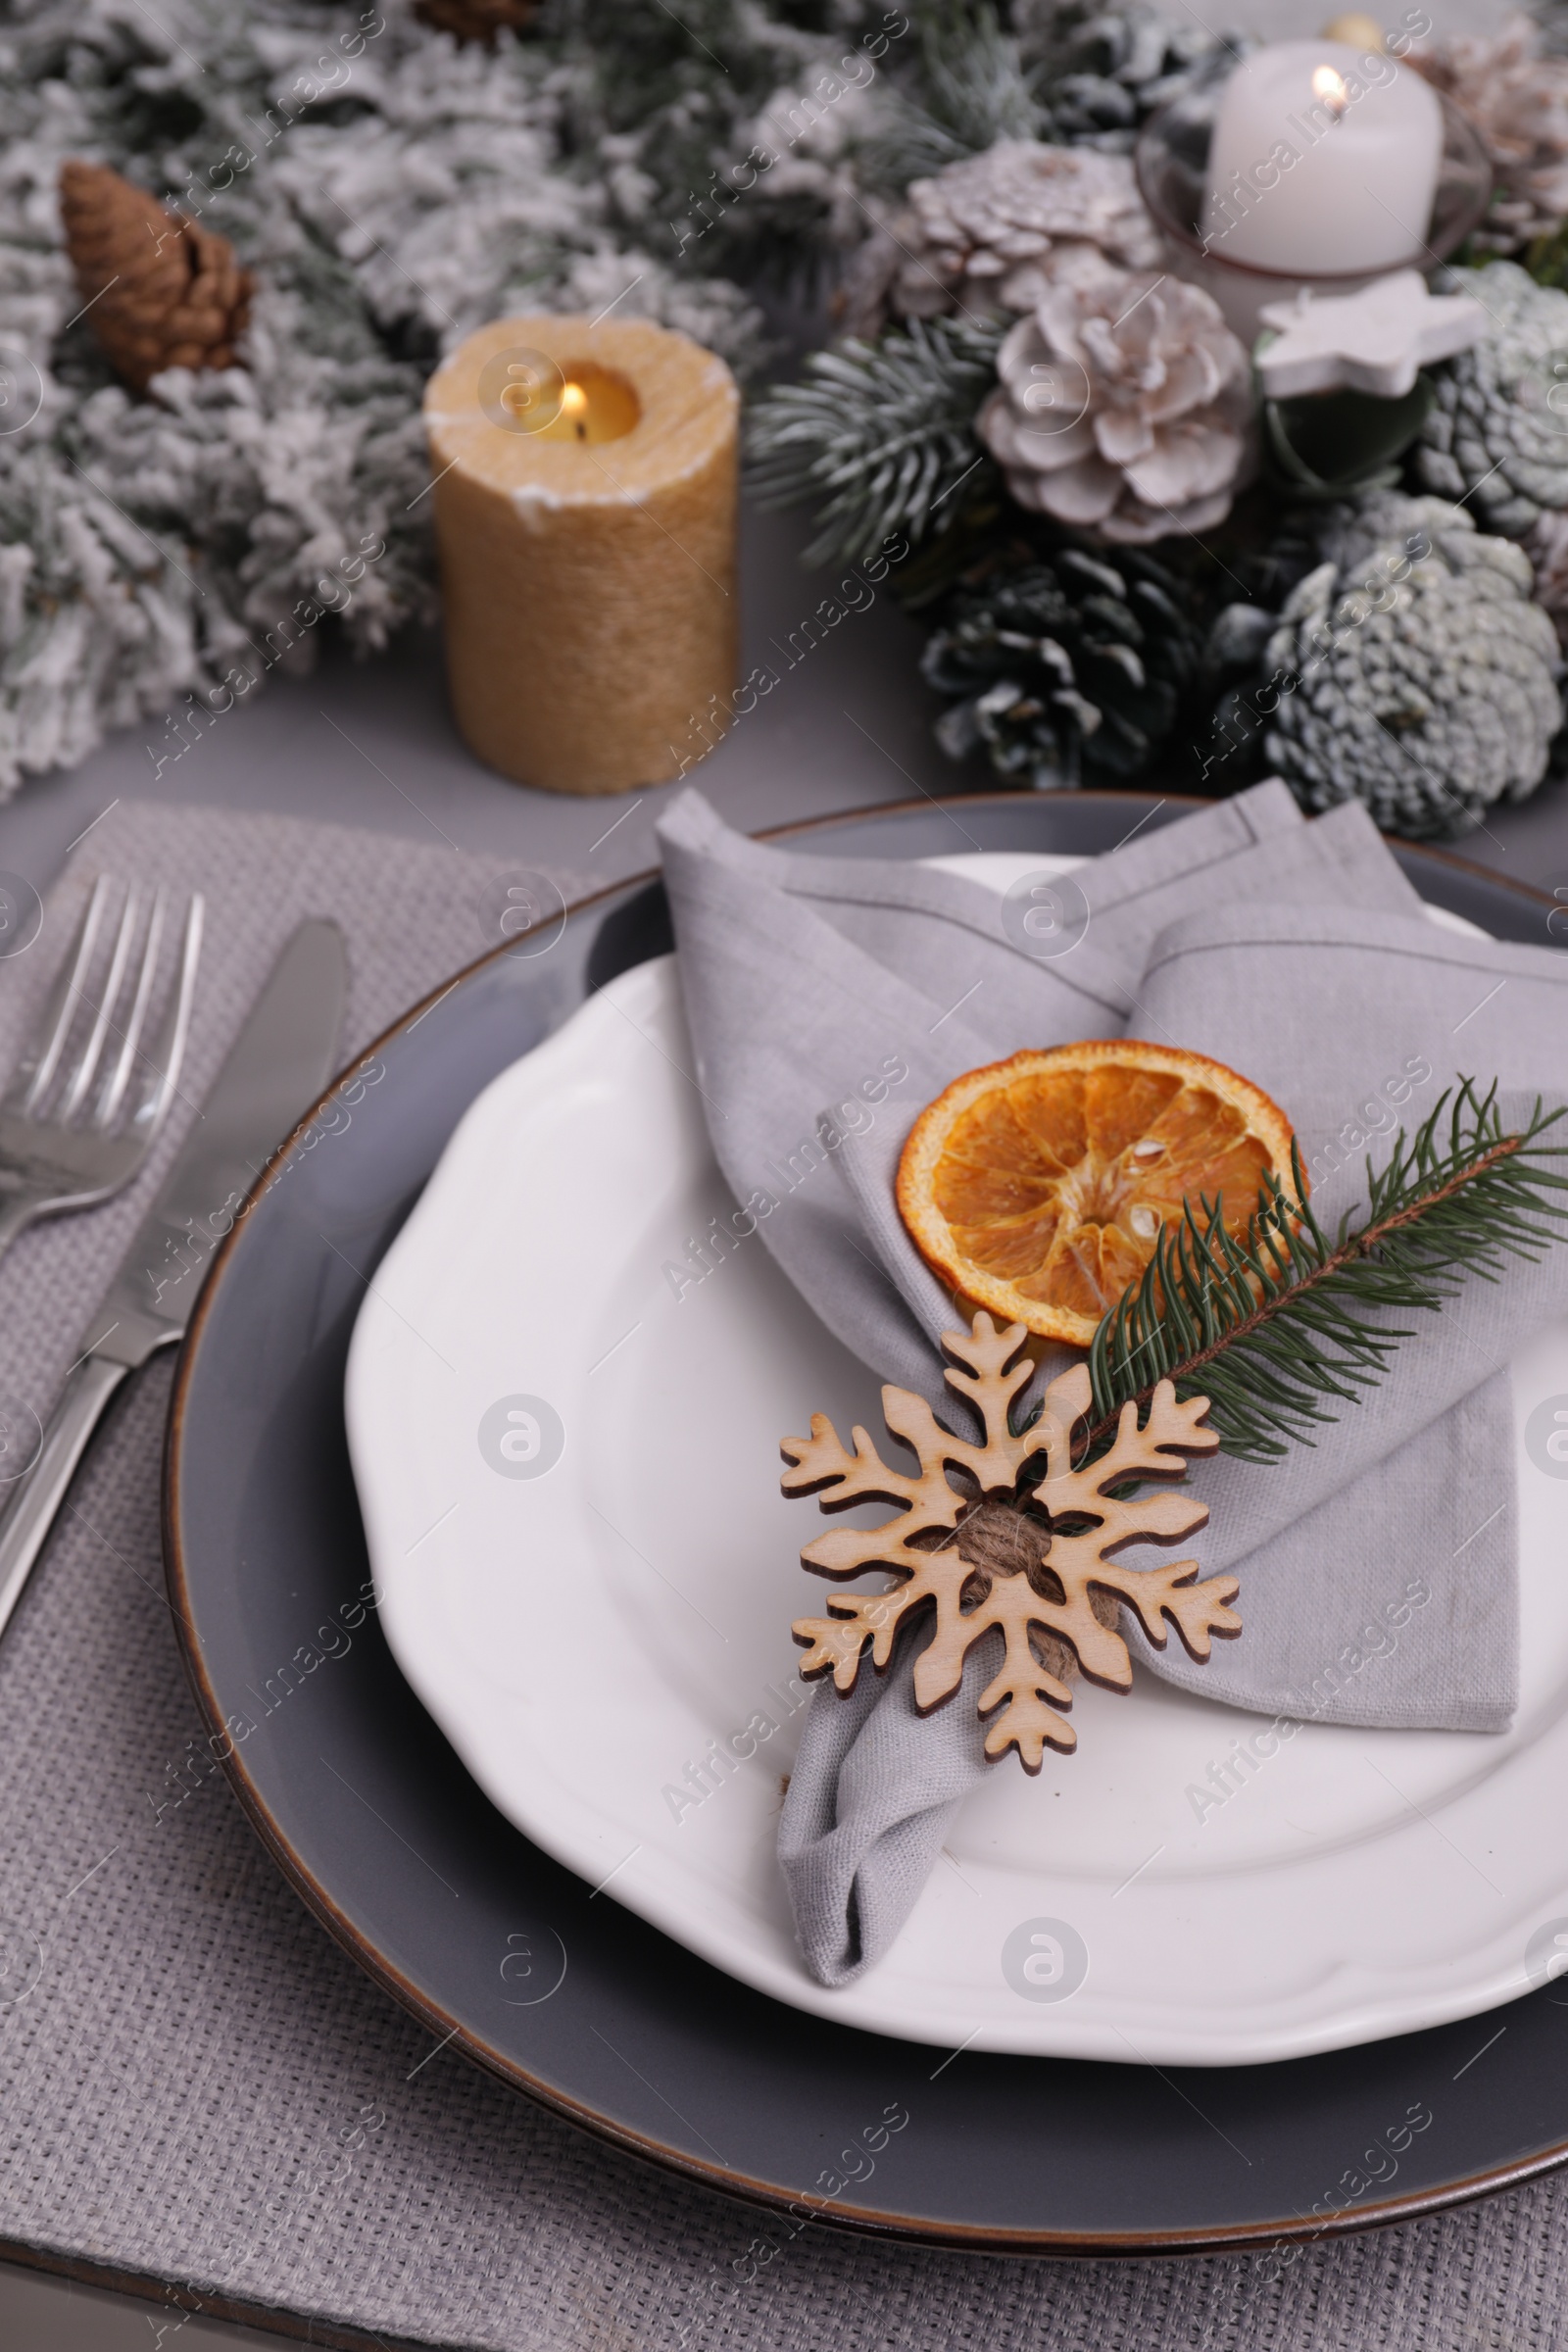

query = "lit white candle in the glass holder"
[[1203, 40, 1444, 277]]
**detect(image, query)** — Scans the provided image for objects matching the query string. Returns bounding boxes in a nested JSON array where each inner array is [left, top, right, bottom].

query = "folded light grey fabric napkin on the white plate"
[[661, 786, 1568, 1983]]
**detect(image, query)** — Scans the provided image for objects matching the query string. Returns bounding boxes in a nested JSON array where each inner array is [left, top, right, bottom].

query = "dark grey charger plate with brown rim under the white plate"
[[165, 793, 1568, 2263]]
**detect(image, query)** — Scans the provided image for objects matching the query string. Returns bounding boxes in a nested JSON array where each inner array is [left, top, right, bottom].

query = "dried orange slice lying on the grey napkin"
[[898, 1037, 1291, 1348]]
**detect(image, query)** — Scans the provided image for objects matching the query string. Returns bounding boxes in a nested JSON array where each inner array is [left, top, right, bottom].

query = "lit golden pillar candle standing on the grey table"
[[425, 318, 741, 793]]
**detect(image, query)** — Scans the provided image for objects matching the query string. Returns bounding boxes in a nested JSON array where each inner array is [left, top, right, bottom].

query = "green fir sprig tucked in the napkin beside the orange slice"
[[1089, 1080, 1568, 1463]]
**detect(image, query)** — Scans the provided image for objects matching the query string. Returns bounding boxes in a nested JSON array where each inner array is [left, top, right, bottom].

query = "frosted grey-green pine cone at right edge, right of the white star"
[[1417, 261, 1568, 539]]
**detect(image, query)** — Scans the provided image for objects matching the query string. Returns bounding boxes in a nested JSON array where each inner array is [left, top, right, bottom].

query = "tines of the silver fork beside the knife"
[[0, 875, 202, 1136]]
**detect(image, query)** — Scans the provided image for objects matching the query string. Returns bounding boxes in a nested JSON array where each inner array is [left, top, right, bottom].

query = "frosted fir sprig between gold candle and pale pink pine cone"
[[748, 318, 1002, 564]]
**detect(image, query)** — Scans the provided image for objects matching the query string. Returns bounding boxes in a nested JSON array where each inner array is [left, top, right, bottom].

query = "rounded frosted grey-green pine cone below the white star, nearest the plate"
[[1249, 492, 1563, 840]]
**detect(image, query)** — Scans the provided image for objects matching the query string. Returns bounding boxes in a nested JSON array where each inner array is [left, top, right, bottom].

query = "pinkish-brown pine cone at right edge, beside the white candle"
[[1408, 17, 1568, 254]]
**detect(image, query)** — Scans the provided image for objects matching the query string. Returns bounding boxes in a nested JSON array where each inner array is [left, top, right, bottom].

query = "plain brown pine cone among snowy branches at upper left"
[[59, 163, 254, 393]]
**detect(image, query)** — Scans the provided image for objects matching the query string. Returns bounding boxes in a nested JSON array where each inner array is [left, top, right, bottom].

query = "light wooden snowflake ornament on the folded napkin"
[[780, 1315, 1242, 1771]]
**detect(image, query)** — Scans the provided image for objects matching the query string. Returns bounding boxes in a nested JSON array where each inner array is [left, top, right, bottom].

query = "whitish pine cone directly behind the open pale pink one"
[[889, 139, 1161, 318]]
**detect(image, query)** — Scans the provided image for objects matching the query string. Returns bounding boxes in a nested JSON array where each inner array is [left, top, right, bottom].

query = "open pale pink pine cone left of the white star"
[[976, 266, 1253, 546]]
